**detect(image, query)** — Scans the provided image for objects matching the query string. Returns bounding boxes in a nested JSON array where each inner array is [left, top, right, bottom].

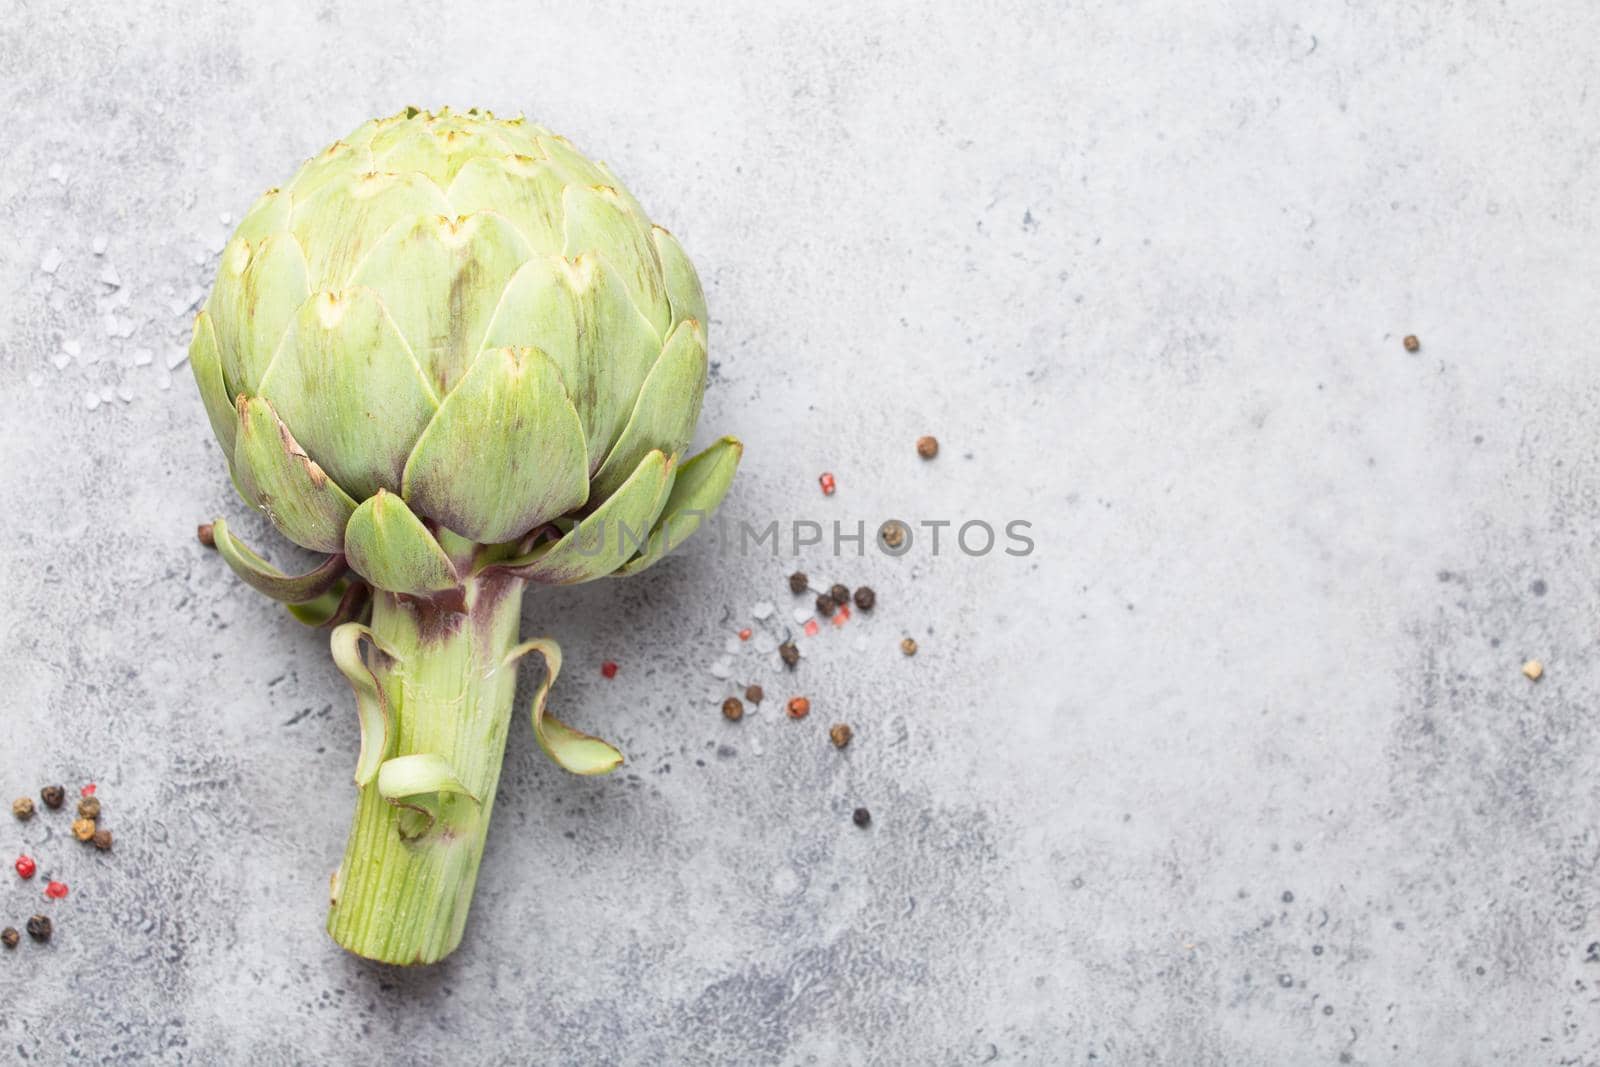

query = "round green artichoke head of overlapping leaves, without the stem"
[[190, 109, 741, 607]]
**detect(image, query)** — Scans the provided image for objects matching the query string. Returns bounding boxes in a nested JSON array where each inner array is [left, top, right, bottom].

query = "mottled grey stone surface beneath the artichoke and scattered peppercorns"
[[0, 0, 1600, 1064]]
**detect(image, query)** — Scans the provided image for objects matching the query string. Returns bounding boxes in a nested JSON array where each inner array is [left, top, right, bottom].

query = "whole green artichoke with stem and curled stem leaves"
[[190, 109, 741, 963]]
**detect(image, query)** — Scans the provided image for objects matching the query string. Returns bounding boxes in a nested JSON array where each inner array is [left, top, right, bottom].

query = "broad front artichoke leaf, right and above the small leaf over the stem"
[[402, 349, 589, 544]]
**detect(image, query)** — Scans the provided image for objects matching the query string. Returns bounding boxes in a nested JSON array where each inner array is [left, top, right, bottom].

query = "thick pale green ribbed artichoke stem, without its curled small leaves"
[[328, 577, 525, 965]]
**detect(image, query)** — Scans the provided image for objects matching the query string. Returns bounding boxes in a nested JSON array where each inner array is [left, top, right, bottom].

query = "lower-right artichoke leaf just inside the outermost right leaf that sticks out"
[[493, 451, 674, 585]]
